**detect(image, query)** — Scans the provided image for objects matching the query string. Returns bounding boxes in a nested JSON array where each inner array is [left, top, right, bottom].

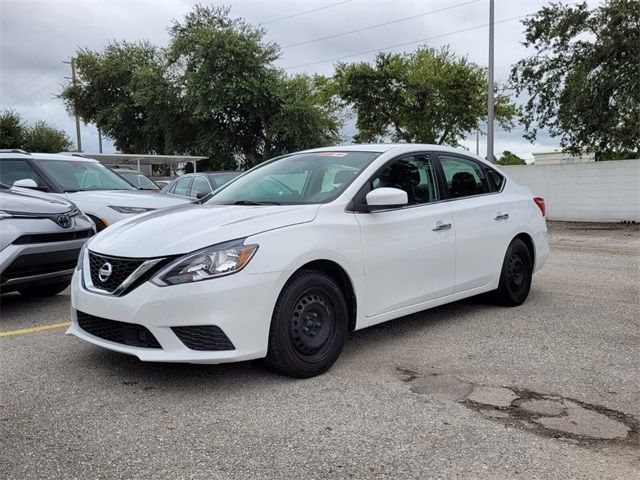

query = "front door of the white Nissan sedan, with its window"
[[356, 154, 455, 323]]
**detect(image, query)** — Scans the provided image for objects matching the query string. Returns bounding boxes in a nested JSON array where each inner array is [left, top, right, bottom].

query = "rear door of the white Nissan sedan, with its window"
[[438, 153, 511, 293]]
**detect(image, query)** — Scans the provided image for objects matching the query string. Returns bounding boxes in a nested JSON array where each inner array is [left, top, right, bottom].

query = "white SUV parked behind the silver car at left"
[[0, 150, 188, 231]]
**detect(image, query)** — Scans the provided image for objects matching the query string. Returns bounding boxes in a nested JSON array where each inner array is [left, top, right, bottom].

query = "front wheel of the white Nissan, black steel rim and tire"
[[265, 270, 349, 378]]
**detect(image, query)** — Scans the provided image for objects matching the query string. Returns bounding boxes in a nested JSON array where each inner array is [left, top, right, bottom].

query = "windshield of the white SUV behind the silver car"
[[34, 159, 135, 192]]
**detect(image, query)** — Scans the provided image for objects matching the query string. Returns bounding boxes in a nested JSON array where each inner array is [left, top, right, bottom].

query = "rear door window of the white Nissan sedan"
[[438, 154, 491, 198]]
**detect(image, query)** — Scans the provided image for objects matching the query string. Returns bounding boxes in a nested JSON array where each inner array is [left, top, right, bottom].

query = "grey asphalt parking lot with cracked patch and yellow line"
[[0, 224, 640, 479]]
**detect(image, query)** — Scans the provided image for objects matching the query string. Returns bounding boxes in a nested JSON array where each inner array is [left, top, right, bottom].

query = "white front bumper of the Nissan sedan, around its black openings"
[[67, 270, 286, 363]]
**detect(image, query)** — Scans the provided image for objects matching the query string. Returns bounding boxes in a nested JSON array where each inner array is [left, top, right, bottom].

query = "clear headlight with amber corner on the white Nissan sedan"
[[151, 239, 258, 287]]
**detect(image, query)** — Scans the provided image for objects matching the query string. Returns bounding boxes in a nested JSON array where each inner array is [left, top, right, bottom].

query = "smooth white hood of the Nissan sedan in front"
[[89, 205, 319, 258]]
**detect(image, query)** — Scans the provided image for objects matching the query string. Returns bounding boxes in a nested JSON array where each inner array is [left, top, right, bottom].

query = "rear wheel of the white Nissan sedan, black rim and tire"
[[492, 238, 533, 307]]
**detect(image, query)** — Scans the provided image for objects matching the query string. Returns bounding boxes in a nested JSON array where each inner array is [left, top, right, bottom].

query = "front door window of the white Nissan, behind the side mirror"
[[371, 155, 440, 205]]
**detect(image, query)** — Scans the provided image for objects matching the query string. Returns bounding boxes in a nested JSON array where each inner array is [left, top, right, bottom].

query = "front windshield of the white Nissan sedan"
[[207, 151, 380, 205]]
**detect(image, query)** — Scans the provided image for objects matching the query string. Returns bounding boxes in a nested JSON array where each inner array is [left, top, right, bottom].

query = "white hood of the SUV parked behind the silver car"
[[66, 190, 191, 208]]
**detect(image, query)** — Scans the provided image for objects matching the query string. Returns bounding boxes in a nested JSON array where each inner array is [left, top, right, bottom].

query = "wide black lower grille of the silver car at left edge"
[[0, 248, 80, 283]]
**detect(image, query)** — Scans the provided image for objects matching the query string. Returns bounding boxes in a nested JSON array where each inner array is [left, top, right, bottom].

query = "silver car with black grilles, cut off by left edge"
[[0, 184, 95, 297]]
